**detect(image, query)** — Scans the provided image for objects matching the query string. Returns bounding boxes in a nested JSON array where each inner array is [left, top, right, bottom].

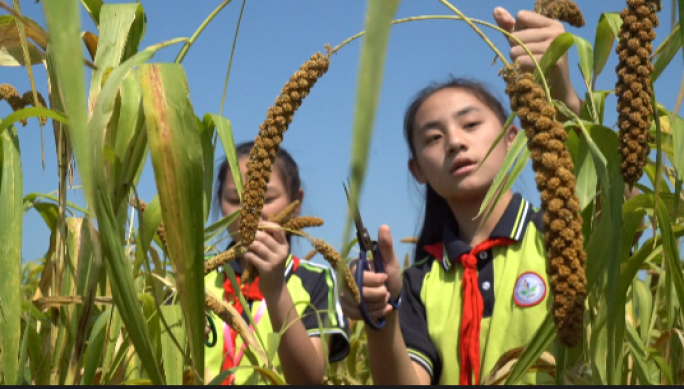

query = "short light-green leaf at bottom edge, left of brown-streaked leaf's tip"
[[161, 305, 187, 385]]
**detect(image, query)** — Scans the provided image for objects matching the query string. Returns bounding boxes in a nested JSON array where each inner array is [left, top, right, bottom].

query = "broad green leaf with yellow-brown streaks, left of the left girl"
[[138, 64, 204, 383]]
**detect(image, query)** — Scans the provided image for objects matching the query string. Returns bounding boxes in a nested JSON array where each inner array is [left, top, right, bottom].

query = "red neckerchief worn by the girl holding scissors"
[[425, 238, 515, 385]]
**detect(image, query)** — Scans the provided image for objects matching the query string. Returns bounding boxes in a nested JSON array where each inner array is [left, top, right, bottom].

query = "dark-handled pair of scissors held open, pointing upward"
[[342, 183, 401, 330]]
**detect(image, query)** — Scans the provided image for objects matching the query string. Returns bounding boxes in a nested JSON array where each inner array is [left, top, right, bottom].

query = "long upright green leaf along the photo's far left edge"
[[0, 123, 24, 383]]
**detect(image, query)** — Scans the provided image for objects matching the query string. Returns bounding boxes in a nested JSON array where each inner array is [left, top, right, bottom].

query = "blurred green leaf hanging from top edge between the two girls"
[[342, 0, 400, 260]]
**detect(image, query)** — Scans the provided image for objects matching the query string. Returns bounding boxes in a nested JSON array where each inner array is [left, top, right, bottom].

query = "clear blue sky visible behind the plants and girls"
[[5, 0, 683, 266]]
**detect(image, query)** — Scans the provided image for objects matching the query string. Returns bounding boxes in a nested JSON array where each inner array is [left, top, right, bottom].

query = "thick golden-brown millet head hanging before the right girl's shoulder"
[[503, 65, 587, 347]]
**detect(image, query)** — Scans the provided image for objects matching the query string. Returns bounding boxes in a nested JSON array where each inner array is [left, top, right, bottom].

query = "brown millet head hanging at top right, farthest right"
[[615, 0, 661, 186]]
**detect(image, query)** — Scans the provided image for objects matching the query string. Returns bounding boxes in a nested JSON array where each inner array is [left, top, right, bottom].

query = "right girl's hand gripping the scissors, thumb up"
[[340, 225, 402, 320]]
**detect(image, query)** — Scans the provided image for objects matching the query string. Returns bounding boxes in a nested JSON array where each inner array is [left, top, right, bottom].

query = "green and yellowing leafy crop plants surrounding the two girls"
[[0, 0, 684, 385]]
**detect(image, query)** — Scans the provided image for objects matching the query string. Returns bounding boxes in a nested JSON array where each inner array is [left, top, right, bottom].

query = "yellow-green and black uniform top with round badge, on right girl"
[[399, 194, 553, 384]]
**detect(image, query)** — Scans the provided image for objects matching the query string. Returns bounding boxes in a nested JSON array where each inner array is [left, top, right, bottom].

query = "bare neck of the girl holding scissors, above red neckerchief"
[[449, 191, 513, 247]]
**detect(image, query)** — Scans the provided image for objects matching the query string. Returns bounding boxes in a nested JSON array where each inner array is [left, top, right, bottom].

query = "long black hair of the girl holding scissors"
[[404, 76, 508, 261]]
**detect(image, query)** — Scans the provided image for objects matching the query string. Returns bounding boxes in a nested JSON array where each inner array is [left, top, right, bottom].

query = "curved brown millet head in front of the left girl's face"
[[240, 52, 330, 283]]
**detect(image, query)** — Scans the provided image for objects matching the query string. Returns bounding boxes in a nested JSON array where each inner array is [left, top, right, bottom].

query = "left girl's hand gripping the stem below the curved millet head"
[[244, 221, 290, 297]]
